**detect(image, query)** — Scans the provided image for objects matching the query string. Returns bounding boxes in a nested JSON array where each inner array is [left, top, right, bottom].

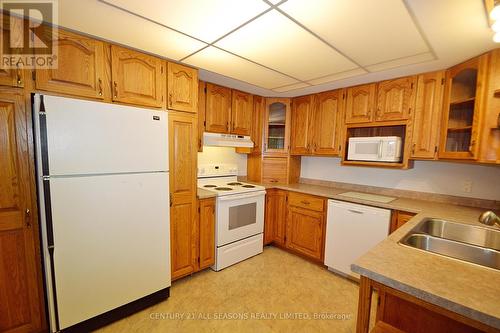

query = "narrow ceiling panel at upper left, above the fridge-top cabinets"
[[59, 0, 206, 60]]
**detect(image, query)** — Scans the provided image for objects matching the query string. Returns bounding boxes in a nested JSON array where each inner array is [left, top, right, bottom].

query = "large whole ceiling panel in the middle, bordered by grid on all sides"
[[215, 10, 355, 80]]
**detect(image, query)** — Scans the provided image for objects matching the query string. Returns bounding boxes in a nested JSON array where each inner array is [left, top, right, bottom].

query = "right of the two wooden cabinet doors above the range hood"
[[230, 90, 253, 135]]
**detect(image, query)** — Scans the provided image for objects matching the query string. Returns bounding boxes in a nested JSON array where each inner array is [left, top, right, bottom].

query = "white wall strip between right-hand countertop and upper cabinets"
[[300, 157, 500, 200]]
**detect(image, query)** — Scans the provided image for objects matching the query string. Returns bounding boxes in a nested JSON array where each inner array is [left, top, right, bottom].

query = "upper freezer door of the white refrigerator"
[[34, 94, 168, 175]]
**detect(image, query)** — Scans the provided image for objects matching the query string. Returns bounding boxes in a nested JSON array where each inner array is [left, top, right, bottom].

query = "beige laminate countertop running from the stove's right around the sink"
[[240, 180, 500, 329]]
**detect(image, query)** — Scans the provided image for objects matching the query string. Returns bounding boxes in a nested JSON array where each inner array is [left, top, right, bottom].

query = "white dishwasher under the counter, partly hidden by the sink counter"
[[325, 200, 391, 277]]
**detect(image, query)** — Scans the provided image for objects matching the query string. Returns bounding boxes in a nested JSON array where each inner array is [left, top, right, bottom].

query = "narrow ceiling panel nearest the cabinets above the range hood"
[[183, 46, 298, 89]]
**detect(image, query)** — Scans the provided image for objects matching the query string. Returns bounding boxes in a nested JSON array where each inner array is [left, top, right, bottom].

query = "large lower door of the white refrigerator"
[[45, 172, 171, 329]]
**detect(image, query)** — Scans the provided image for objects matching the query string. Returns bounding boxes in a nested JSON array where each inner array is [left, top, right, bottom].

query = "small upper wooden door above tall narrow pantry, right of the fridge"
[[167, 62, 198, 113]]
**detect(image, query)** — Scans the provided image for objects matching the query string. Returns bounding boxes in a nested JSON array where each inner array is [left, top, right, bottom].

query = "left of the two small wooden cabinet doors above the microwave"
[[345, 83, 376, 124]]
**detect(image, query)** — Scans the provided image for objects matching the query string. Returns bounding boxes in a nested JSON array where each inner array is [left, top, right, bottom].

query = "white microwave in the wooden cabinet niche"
[[347, 136, 402, 162]]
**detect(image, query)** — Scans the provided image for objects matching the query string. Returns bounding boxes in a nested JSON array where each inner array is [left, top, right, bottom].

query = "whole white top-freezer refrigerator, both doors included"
[[33, 94, 171, 332]]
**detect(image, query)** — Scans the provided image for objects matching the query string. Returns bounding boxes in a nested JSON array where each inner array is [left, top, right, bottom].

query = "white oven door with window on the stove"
[[216, 191, 266, 246]]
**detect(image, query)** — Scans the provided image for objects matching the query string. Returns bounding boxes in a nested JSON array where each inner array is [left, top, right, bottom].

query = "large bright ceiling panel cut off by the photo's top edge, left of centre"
[[104, 0, 269, 43]]
